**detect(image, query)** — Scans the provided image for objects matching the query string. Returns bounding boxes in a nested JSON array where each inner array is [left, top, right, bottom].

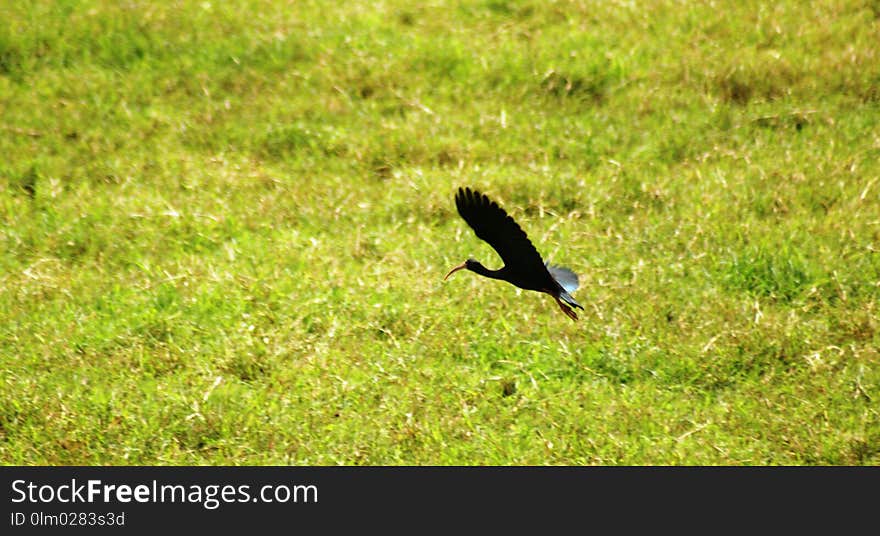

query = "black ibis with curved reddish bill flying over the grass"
[[443, 187, 584, 321]]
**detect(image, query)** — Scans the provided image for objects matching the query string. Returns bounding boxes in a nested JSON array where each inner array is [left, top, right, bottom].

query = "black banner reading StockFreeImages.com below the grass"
[[0, 467, 880, 534]]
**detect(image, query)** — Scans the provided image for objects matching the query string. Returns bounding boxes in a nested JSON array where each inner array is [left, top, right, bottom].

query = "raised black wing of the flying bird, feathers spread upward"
[[455, 188, 544, 269]]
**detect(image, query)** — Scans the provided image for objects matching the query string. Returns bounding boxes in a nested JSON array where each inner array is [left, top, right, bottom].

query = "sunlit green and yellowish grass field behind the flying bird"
[[0, 0, 880, 465]]
